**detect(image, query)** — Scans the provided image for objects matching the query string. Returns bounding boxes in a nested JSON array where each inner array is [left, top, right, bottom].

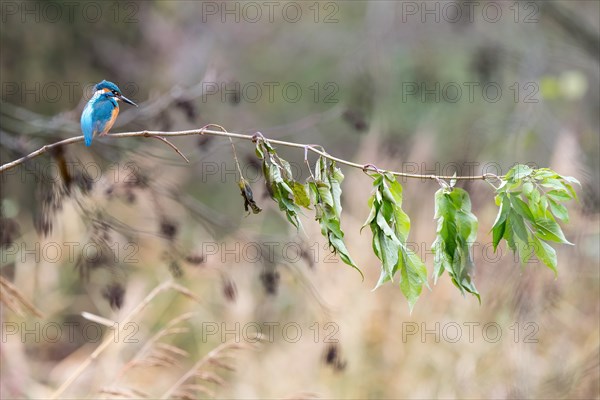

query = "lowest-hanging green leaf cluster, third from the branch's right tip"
[[363, 173, 427, 310]]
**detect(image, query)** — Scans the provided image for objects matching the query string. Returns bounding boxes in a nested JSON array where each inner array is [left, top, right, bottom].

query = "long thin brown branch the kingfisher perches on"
[[0, 124, 502, 181]]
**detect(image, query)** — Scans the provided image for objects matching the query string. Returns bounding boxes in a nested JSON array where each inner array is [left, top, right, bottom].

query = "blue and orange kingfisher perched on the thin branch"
[[81, 80, 137, 146]]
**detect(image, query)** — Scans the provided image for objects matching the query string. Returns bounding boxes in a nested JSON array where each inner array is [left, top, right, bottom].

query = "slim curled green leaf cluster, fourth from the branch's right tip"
[[308, 157, 364, 279]]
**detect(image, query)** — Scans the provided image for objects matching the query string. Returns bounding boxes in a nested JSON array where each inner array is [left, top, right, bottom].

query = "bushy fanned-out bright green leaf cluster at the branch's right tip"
[[492, 164, 579, 274]]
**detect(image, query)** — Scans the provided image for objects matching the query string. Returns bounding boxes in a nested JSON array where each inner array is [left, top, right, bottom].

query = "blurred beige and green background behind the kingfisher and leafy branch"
[[0, 0, 600, 399]]
